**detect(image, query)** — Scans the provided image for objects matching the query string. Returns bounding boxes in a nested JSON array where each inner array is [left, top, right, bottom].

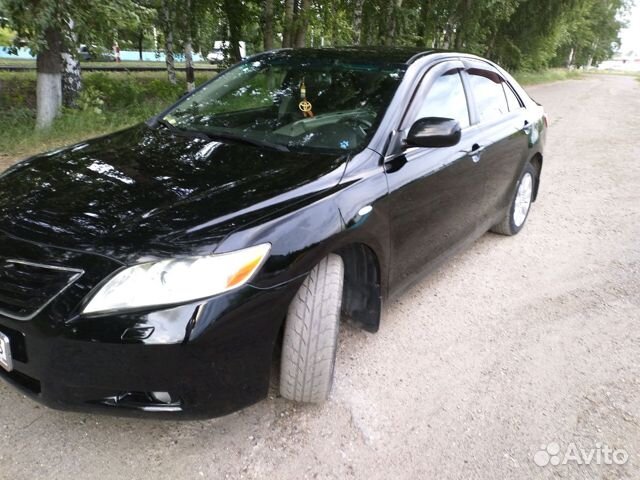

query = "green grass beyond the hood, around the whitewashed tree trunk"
[[0, 72, 214, 163]]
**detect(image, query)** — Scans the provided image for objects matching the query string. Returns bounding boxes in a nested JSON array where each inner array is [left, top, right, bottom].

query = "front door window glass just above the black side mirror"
[[416, 70, 469, 128]]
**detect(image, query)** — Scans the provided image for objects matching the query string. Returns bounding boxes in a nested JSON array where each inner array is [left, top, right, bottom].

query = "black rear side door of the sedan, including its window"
[[464, 62, 531, 224]]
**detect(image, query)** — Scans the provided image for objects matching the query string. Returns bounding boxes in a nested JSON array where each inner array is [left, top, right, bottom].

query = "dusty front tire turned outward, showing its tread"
[[280, 254, 344, 403]]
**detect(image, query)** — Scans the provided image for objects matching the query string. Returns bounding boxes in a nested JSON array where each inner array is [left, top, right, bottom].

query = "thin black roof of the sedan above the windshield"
[[256, 47, 444, 65]]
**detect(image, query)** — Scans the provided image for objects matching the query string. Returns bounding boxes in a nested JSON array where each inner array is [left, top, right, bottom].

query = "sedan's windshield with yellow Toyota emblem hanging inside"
[[161, 53, 406, 151]]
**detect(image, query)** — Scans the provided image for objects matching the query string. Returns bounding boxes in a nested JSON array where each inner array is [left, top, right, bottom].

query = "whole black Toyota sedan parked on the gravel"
[[0, 48, 547, 416]]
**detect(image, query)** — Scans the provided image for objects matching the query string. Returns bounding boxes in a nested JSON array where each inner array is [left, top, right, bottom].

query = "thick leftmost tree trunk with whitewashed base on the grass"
[[36, 28, 62, 129]]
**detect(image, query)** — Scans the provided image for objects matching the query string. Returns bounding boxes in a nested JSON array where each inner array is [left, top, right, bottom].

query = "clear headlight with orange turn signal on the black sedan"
[[82, 243, 271, 314]]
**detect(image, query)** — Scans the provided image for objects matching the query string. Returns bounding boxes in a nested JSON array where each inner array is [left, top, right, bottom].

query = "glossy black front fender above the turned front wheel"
[[216, 152, 389, 295]]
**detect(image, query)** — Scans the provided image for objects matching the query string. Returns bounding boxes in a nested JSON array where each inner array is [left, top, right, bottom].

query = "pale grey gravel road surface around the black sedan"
[[0, 76, 640, 480]]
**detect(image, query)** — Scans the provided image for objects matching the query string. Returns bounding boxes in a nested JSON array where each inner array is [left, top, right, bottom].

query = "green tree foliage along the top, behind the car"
[[0, 0, 632, 69]]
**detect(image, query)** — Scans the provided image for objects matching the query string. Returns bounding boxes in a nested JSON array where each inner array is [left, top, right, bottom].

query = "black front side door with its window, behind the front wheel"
[[385, 61, 486, 289]]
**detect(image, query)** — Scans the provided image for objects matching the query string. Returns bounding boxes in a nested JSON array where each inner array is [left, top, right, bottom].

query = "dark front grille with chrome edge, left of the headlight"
[[0, 258, 83, 320]]
